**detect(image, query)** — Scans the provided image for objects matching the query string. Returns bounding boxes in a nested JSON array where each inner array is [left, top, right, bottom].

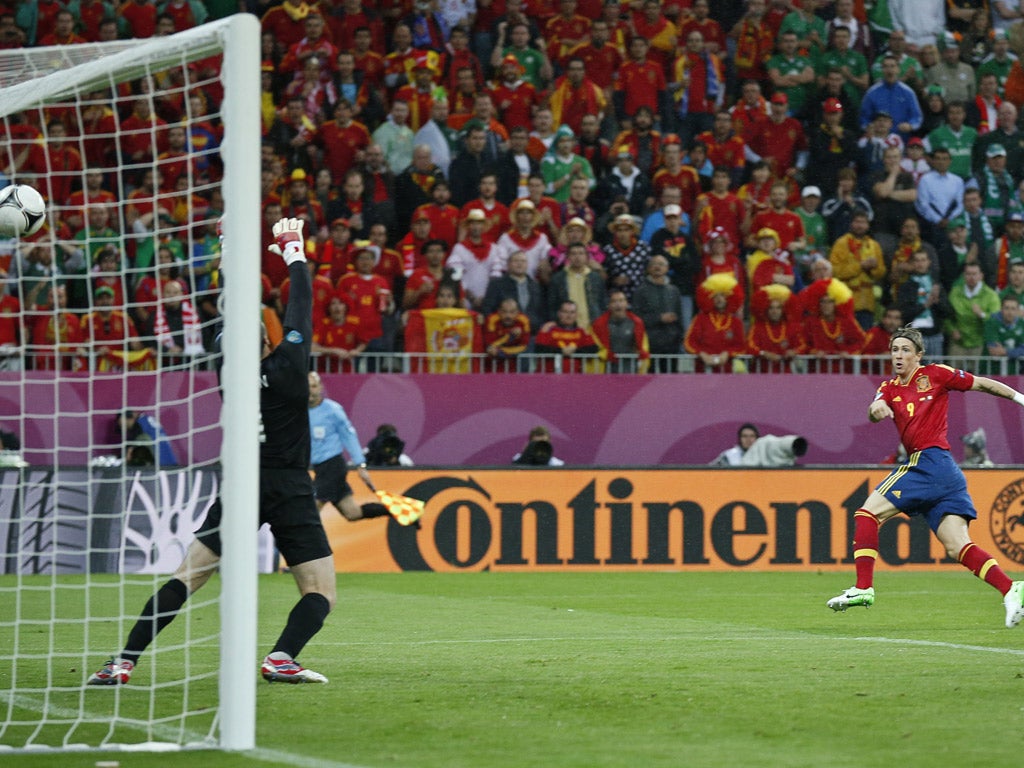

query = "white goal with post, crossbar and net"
[[0, 14, 260, 755]]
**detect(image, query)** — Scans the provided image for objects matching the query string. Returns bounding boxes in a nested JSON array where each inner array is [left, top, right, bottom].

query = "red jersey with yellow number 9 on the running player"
[[874, 365, 974, 454]]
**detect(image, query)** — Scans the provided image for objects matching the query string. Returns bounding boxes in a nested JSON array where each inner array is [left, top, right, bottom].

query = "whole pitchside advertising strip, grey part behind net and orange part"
[[8, 467, 1024, 574]]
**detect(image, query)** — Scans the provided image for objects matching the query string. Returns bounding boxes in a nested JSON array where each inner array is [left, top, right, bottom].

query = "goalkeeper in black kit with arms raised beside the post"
[[88, 219, 335, 685]]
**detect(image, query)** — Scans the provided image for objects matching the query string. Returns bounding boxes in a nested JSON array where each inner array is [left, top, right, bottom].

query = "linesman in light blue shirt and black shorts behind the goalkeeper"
[[309, 371, 390, 521]]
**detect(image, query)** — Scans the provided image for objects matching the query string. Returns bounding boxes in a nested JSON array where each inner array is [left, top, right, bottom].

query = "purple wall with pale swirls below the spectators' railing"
[[0, 372, 1024, 467]]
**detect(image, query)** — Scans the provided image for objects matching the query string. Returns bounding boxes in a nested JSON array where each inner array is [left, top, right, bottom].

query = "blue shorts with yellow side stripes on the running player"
[[874, 447, 978, 530]]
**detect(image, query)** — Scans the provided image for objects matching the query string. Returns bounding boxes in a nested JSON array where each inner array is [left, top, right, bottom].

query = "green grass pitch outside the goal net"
[[0, 567, 1024, 768]]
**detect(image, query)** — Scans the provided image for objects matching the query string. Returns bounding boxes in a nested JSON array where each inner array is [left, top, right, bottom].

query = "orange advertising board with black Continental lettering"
[[324, 467, 1024, 572]]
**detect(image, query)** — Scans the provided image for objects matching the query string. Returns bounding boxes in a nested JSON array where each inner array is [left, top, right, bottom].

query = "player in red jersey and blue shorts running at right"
[[826, 327, 1024, 628]]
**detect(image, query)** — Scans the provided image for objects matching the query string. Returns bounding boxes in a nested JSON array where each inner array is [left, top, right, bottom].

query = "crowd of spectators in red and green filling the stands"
[[0, 0, 1024, 372]]
